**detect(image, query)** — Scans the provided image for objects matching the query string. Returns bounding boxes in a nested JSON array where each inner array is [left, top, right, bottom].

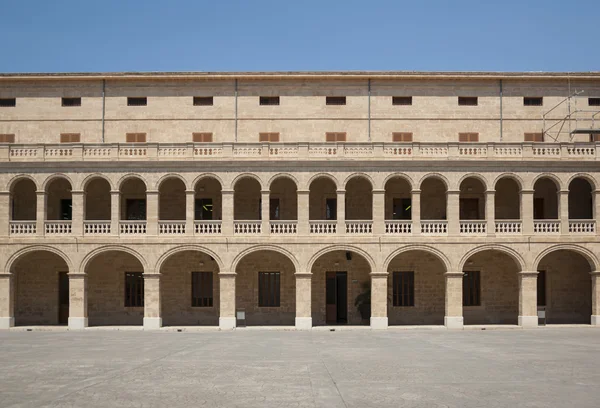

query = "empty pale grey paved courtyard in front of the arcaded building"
[[0, 328, 600, 408]]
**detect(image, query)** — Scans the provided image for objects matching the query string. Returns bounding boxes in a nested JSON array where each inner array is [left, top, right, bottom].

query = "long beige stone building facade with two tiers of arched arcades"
[[0, 72, 600, 329]]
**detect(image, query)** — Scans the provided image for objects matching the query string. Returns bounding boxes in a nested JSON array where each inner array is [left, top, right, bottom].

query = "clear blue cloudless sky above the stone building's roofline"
[[0, 0, 600, 72]]
